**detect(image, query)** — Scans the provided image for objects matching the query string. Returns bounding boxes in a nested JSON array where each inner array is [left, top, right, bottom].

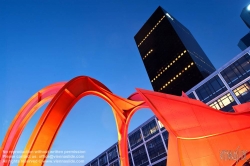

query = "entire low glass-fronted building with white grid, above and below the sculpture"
[[86, 47, 250, 166]]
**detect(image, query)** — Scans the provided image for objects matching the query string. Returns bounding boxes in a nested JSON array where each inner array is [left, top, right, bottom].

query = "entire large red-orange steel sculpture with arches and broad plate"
[[0, 76, 250, 166]]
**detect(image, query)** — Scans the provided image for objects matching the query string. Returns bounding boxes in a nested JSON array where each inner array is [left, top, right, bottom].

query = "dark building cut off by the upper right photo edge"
[[238, 5, 250, 51]]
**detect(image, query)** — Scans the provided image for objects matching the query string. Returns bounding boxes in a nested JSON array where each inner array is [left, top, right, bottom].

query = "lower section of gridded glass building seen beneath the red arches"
[[85, 117, 168, 166]]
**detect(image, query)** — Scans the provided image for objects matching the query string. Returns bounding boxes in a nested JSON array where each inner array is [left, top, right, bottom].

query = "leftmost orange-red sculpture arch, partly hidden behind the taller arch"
[[0, 82, 65, 166]]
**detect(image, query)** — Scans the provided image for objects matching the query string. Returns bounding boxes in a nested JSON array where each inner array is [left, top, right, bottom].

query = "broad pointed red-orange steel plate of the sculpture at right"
[[137, 89, 250, 166]]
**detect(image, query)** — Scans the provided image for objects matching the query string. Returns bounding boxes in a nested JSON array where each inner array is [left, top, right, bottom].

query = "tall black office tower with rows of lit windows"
[[134, 7, 215, 95]]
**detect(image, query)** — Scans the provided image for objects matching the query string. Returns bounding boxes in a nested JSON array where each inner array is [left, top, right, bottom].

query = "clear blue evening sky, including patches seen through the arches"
[[0, 0, 250, 163]]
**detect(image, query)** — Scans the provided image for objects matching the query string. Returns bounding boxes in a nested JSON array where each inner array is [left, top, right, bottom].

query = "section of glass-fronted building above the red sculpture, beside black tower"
[[187, 48, 250, 112]]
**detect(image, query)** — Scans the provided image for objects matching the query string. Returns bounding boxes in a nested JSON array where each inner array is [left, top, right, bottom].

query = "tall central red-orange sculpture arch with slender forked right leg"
[[19, 76, 143, 166]]
